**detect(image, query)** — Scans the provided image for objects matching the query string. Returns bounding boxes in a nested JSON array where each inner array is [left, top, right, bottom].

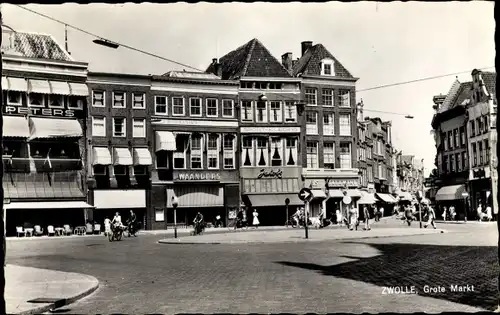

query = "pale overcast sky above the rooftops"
[[2, 1, 495, 178]]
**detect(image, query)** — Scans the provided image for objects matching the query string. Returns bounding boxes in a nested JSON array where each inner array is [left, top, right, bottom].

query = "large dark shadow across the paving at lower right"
[[276, 242, 498, 310]]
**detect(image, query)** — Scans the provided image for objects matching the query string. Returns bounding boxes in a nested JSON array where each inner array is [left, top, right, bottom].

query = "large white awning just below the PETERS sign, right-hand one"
[[29, 118, 83, 140]]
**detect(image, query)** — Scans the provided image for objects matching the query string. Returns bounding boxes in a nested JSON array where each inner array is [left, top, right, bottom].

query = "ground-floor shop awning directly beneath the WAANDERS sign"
[[167, 185, 224, 210]]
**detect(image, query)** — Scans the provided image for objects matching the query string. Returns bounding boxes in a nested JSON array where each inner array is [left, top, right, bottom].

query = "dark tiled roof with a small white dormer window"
[[293, 44, 354, 78]]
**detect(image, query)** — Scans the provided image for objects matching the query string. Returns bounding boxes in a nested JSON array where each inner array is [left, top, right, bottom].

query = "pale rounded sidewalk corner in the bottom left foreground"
[[5, 265, 99, 315]]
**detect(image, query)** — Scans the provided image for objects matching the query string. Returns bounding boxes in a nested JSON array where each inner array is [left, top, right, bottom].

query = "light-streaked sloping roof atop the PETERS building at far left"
[[2, 30, 74, 61]]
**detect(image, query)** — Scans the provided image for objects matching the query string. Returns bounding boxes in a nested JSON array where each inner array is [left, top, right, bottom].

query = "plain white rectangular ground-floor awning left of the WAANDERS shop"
[[94, 189, 146, 211]]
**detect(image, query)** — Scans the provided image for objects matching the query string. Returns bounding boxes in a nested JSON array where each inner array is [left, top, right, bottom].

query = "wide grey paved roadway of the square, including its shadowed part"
[[7, 224, 498, 314]]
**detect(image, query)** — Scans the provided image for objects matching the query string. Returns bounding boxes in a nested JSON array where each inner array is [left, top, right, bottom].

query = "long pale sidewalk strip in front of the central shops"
[[158, 227, 446, 244]]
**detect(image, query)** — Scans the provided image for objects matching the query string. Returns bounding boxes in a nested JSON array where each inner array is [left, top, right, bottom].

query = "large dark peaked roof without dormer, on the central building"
[[206, 38, 291, 80]]
